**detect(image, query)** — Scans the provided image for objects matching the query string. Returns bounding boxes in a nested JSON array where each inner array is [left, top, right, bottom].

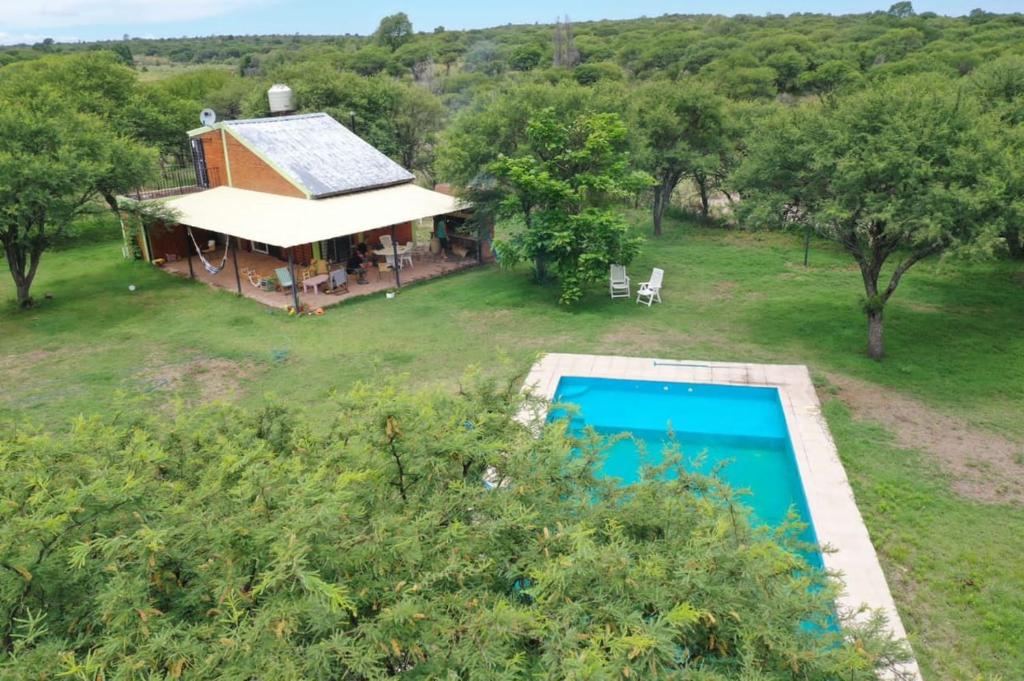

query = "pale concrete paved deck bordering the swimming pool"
[[523, 353, 922, 681]]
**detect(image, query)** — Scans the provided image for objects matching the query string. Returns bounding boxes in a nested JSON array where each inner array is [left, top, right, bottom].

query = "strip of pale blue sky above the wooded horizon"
[[0, 0, 1024, 44]]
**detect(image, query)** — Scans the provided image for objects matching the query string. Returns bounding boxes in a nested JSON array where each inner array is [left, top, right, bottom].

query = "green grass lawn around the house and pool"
[[0, 210, 1024, 681]]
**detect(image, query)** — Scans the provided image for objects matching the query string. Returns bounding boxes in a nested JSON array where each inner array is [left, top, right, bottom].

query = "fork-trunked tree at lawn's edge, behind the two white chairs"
[[635, 81, 736, 236]]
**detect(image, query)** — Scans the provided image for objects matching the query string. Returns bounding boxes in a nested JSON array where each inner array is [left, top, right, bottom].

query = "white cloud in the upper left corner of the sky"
[[0, 0, 268, 30]]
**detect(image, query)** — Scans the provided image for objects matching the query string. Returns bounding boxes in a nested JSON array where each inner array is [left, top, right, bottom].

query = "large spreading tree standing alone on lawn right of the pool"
[[733, 77, 997, 359]]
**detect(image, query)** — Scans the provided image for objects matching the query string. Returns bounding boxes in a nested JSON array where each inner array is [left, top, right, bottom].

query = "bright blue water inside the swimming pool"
[[551, 376, 821, 566]]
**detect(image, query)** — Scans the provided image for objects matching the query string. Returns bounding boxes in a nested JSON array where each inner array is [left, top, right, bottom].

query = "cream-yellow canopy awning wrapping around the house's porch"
[[163, 183, 466, 248]]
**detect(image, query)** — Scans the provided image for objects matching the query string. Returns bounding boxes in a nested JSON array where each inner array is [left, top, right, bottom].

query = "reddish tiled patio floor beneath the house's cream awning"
[[163, 249, 477, 309]]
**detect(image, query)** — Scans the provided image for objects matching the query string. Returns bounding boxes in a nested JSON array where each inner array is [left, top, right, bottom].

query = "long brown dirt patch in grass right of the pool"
[[822, 375, 1024, 504]]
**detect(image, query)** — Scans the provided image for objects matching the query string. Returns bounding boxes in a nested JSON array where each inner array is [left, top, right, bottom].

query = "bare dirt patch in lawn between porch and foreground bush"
[[136, 357, 255, 403]]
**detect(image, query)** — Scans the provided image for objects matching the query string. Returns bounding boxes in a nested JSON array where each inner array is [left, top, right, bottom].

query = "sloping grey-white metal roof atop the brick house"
[[221, 114, 415, 199]]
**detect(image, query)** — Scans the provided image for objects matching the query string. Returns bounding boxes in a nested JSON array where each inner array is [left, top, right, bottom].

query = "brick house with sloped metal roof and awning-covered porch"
[[139, 114, 489, 307]]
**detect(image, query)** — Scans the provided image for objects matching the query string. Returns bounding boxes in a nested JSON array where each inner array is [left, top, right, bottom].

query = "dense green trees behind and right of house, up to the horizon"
[[0, 7, 1024, 350]]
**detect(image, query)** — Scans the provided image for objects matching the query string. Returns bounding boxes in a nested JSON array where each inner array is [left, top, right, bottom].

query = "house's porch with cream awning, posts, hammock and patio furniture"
[[143, 184, 490, 310]]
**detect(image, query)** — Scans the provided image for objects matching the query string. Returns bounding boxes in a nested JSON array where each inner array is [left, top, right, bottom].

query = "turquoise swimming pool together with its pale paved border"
[[520, 352, 921, 681]]
